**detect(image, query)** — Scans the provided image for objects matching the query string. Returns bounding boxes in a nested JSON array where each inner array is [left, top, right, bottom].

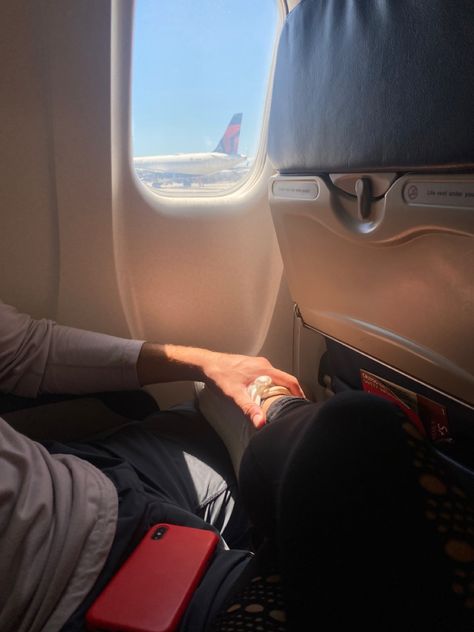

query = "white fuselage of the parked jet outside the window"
[[133, 152, 245, 176]]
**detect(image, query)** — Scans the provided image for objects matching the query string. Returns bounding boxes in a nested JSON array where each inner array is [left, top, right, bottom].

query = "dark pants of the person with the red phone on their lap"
[[45, 406, 251, 632]]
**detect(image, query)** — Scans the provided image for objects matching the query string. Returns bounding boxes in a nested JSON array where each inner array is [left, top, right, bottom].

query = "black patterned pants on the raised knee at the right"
[[237, 393, 474, 632]]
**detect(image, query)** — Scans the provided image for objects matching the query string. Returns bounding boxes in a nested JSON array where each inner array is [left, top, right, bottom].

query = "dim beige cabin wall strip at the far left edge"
[[0, 2, 59, 317]]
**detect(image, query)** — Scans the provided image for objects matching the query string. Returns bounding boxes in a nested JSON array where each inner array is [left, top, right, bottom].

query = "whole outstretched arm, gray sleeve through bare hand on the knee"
[[0, 302, 303, 427]]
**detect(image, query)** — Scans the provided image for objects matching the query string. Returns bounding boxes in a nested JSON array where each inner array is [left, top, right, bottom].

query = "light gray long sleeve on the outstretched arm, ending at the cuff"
[[0, 301, 143, 397]]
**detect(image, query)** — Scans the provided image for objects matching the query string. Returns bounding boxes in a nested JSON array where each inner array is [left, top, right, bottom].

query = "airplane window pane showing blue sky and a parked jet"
[[132, 0, 282, 195]]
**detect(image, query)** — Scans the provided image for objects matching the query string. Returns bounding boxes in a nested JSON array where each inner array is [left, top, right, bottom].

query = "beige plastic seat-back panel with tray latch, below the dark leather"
[[270, 175, 474, 404]]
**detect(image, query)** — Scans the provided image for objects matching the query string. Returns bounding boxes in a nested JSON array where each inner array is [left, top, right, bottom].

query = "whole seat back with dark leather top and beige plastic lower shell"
[[268, 0, 474, 454]]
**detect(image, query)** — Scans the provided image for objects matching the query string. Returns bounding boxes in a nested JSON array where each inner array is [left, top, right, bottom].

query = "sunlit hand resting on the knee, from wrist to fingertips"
[[202, 352, 304, 428]]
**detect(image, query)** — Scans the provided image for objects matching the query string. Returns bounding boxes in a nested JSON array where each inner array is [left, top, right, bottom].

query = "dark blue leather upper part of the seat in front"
[[268, 0, 474, 174]]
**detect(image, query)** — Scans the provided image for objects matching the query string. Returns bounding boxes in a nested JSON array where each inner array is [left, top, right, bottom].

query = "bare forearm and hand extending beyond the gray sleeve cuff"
[[137, 342, 304, 428]]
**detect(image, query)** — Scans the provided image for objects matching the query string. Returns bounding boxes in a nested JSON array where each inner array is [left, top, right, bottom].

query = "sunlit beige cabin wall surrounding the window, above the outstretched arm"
[[0, 0, 292, 404]]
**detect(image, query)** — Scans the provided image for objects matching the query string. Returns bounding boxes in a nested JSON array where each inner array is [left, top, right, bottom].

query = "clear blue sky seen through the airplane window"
[[132, 0, 278, 156]]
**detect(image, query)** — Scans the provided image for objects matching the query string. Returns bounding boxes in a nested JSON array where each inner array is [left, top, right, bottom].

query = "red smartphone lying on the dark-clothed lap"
[[86, 523, 219, 632]]
